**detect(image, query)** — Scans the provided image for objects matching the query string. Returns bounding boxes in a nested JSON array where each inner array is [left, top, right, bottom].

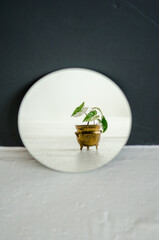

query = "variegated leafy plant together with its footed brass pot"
[[71, 102, 108, 150]]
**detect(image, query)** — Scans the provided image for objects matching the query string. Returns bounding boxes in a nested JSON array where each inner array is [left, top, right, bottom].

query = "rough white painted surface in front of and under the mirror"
[[0, 146, 159, 240]]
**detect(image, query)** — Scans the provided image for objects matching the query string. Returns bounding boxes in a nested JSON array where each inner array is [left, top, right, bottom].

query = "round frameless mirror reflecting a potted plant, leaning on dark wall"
[[18, 68, 132, 172]]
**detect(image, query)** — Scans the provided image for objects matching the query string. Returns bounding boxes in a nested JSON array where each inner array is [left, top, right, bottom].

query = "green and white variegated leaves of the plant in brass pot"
[[71, 102, 108, 133]]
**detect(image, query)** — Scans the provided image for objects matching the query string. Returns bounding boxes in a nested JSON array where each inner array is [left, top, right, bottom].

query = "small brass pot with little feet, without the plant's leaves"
[[75, 125, 102, 150]]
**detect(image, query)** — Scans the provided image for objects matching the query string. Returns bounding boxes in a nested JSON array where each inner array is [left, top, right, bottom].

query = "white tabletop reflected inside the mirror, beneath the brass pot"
[[19, 135, 127, 172]]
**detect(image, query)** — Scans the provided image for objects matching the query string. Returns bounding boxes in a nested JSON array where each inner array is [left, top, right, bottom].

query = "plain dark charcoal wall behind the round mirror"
[[0, 0, 159, 146]]
